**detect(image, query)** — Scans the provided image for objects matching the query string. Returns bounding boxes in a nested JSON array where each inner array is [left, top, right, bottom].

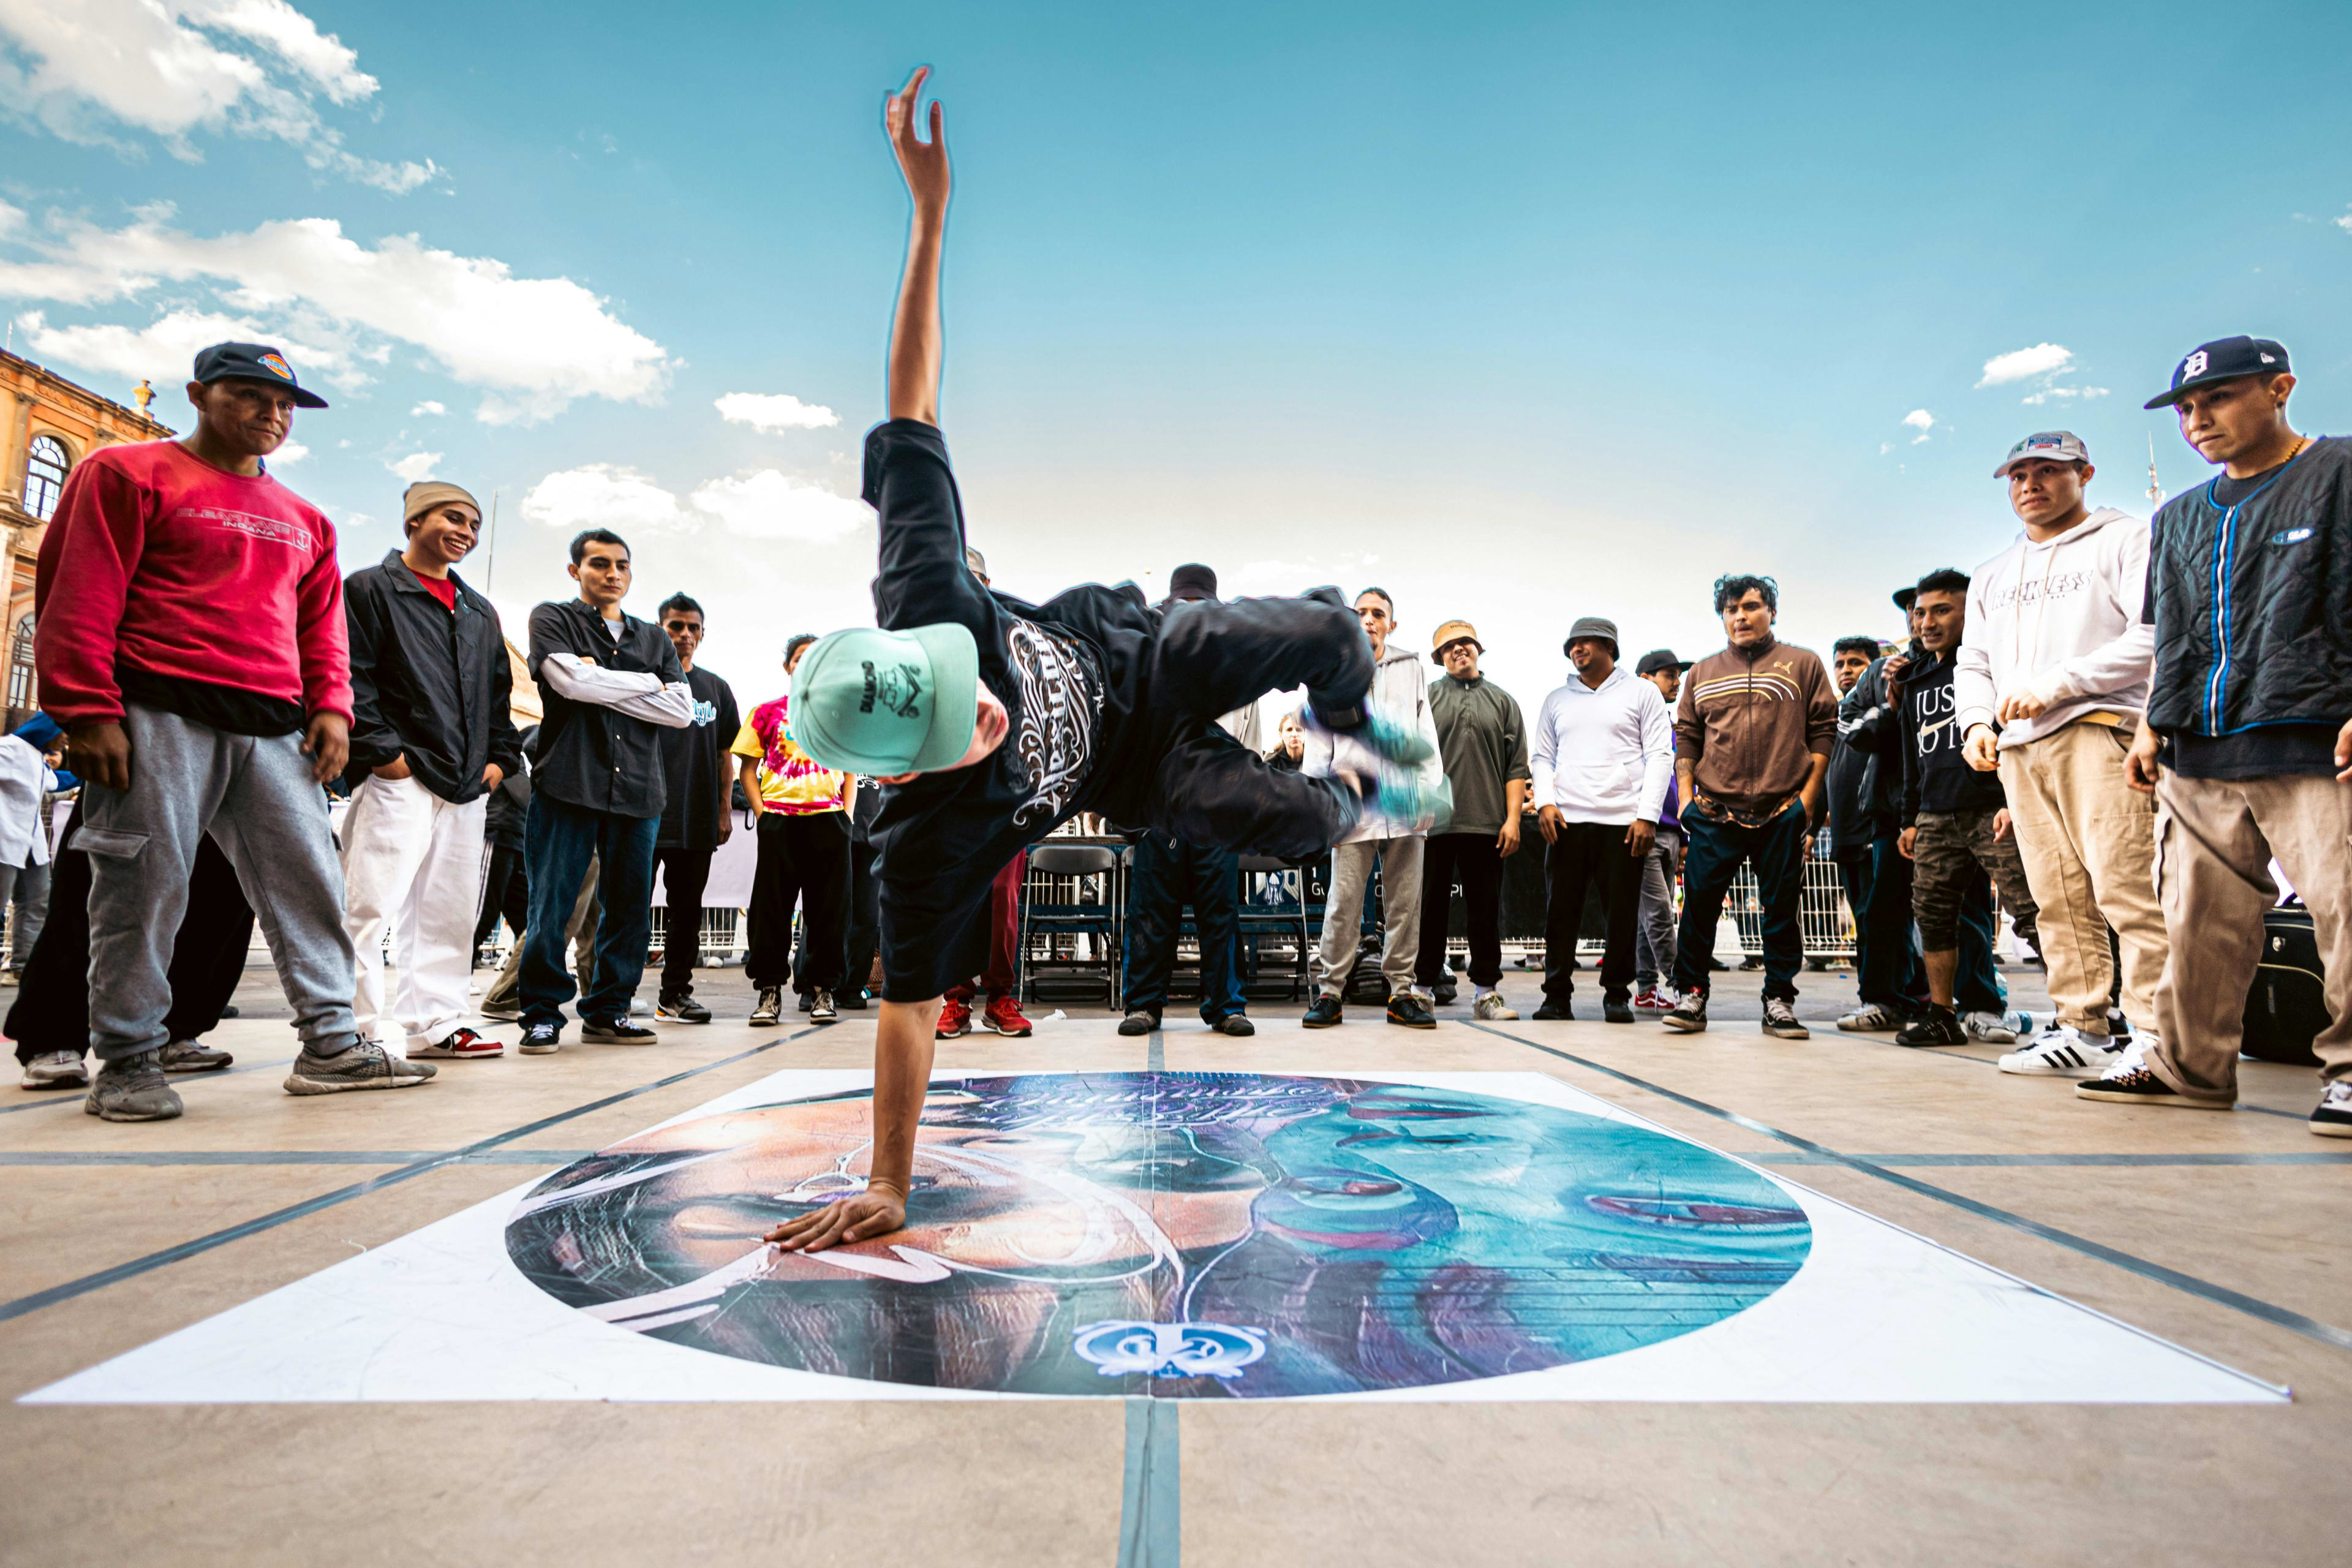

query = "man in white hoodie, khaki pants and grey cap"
[[1952, 430, 2168, 1079]]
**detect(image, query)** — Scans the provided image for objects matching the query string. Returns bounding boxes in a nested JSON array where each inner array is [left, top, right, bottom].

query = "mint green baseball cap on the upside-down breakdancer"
[[786, 620, 981, 776]]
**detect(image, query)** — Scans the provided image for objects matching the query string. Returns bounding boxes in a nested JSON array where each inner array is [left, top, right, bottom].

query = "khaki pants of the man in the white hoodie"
[[2002, 724, 2168, 1035]]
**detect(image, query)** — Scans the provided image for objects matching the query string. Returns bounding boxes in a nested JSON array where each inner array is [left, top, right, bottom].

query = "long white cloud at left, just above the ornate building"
[[0, 211, 670, 426]]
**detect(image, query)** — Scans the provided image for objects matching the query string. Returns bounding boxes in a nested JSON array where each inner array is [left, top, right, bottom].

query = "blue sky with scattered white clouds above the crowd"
[[0, 0, 2352, 703]]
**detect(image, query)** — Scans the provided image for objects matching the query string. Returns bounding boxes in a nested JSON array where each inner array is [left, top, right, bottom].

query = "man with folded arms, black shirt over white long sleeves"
[[522, 529, 694, 1055]]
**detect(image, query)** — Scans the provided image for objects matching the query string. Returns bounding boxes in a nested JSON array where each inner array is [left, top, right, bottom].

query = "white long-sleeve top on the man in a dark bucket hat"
[[1526, 665, 1675, 823]]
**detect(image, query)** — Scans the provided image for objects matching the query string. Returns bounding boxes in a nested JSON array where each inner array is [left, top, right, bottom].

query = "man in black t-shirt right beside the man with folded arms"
[[654, 592, 743, 1023]]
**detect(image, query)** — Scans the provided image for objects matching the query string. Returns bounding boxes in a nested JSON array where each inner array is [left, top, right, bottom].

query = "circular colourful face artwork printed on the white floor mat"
[[506, 1072, 1814, 1399]]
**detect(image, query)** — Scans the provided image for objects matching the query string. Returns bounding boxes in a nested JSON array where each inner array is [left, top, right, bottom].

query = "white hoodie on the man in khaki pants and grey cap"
[[1952, 505, 2157, 748]]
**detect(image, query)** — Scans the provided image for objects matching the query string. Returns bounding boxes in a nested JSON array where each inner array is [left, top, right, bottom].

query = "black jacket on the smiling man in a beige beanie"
[[344, 550, 522, 806]]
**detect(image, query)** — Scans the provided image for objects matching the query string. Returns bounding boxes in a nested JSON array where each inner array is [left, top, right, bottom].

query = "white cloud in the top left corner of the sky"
[[0, 0, 442, 195]]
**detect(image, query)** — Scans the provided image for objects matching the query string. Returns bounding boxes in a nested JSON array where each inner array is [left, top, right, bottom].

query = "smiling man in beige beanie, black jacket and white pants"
[[344, 480, 522, 1058]]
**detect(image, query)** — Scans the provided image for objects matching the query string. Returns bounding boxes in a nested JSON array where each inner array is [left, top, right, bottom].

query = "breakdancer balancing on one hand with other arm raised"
[[767, 68, 1434, 1251]]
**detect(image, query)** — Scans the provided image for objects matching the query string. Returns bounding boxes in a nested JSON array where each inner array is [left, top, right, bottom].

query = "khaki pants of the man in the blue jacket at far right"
[[2147, 774, 2352, 1102]]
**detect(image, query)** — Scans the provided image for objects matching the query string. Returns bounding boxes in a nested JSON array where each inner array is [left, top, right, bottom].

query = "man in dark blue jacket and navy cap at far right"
[[2075, 336, 2352, 1138]]
